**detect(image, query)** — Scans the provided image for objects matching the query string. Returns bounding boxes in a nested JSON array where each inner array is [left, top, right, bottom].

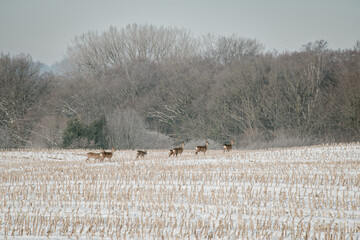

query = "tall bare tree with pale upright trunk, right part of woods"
[[280, 51, 328, 136]]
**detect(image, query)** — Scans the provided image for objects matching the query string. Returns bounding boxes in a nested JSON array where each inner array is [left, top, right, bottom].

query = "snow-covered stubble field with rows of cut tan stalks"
[[0, 143, 360, 239]]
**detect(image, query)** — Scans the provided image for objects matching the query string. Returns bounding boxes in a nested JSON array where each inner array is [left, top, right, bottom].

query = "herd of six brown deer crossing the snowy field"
[[86, 140, 235, 162]]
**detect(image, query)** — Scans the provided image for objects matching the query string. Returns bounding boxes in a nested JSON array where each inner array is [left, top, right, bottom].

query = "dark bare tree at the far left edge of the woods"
[[0, 54, 49, 147]]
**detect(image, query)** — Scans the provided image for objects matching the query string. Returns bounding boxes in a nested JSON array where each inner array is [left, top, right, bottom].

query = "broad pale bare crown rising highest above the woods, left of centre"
[[68, 24, 196, 74]]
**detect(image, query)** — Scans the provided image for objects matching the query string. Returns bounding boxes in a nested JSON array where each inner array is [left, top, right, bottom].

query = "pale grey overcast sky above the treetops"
[[0, 0, 360, 65]]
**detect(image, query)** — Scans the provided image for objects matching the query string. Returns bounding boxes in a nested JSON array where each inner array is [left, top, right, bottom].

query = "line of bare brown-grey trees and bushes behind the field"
[[0, 24, 360, 149]]
